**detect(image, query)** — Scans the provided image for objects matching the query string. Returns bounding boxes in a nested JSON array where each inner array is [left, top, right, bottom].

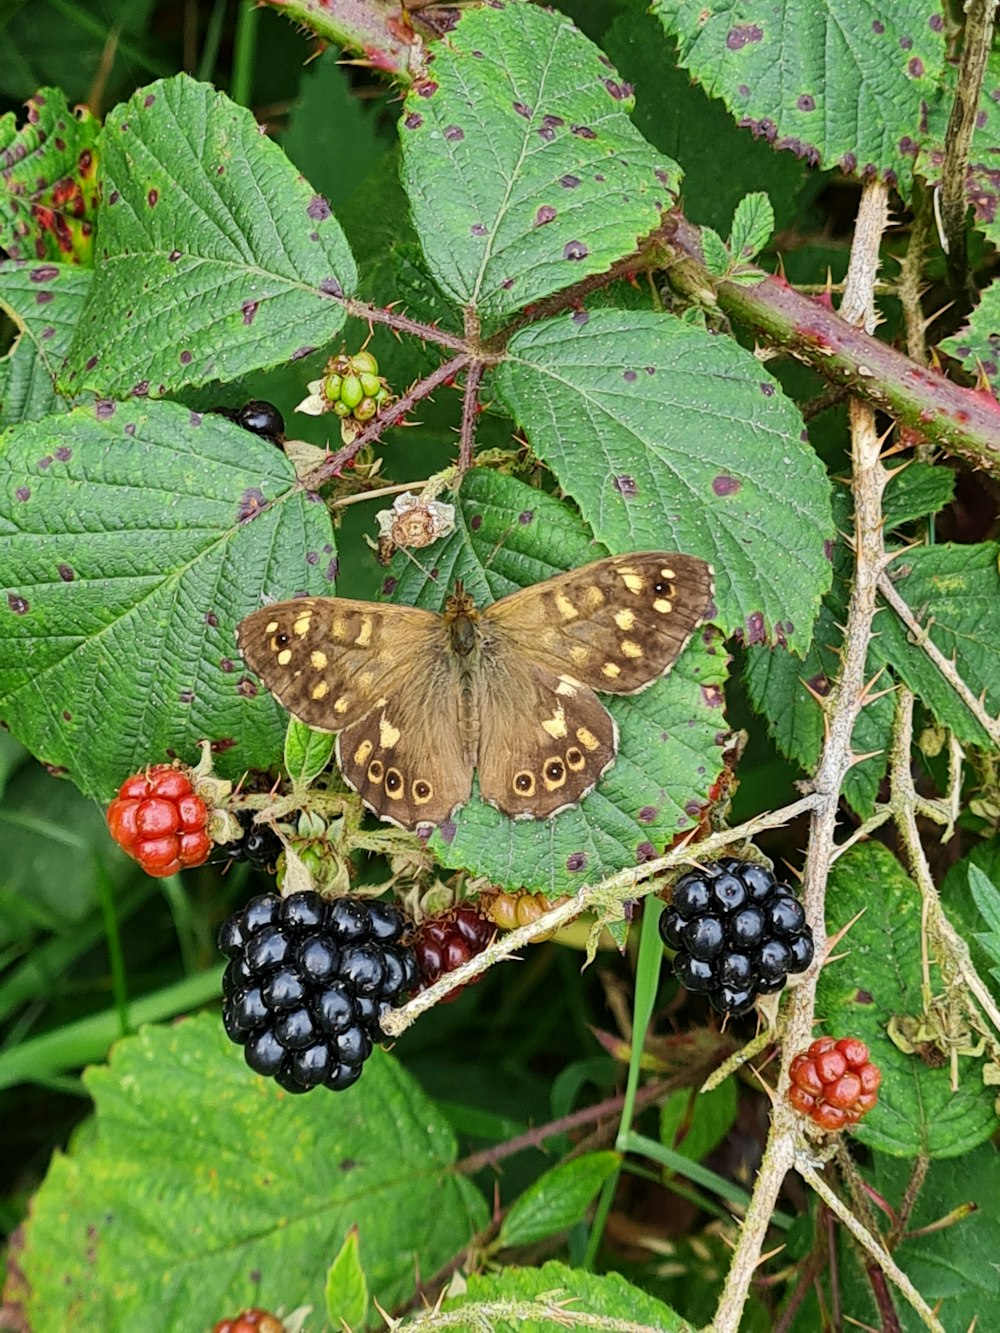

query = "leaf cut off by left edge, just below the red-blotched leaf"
[[0, 260, 93, 428]]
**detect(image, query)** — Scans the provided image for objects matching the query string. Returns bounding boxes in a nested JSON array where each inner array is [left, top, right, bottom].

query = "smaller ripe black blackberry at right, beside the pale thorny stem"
[[660, 857, 813, 1014]]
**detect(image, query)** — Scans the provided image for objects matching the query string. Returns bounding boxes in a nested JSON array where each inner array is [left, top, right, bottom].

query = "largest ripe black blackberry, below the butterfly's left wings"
[[219, 889, 416, 1093]]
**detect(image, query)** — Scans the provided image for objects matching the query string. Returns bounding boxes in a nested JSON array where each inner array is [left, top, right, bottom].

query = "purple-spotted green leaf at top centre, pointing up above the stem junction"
[[400, 4, 680, 327]]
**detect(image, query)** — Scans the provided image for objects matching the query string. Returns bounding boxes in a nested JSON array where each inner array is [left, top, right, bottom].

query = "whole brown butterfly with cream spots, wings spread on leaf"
[[237, 551, 713, 829]]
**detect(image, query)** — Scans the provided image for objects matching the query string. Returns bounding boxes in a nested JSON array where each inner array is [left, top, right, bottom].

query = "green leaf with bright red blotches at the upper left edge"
[[0, 87, 100, 267]]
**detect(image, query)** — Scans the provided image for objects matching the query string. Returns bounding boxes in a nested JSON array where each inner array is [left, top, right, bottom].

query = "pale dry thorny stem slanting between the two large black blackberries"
[[381, 796, 817, 1037]]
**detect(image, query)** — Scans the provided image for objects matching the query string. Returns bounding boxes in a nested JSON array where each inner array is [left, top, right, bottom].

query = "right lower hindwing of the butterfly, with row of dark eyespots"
[[477, 650, 619, 820]]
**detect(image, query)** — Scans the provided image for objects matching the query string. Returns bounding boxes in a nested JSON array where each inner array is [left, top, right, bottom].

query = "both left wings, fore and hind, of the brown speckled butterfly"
[[237, 597, 475, 828]]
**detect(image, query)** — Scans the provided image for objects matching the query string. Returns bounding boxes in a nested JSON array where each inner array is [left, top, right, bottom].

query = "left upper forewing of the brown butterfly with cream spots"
[[236, 597, 445, 732]]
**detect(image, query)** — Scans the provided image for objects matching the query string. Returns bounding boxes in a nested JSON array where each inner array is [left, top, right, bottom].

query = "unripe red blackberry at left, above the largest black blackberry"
[[107, 764, 212, 878]]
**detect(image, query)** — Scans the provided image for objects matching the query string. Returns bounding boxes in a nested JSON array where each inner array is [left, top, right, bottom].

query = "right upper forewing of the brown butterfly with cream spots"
[[483, 551, 713, 694]]
